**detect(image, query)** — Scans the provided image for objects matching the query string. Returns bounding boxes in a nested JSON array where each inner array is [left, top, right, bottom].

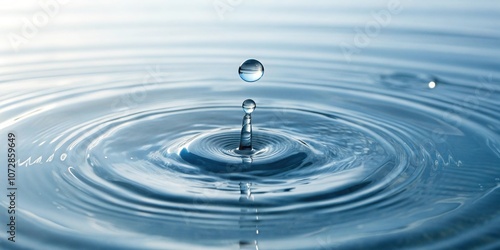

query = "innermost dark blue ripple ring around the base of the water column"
[[176, 130, 311, 178]]
